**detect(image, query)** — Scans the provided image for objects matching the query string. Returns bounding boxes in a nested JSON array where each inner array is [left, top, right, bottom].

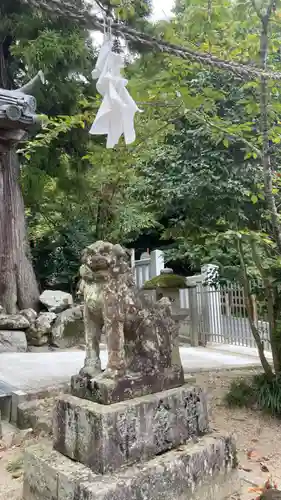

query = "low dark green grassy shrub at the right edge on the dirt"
[[225, 373, 281, 418]]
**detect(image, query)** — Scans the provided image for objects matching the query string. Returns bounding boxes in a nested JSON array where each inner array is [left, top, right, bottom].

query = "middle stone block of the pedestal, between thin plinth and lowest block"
[[53, 386, 208, 474]]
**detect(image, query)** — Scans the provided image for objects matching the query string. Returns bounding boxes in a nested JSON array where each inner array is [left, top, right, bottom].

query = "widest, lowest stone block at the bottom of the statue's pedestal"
[[23, 436, 239, 500]]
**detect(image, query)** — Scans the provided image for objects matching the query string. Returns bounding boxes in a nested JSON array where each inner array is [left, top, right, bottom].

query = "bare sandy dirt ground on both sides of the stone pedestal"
[[0, 371, 281, 500]]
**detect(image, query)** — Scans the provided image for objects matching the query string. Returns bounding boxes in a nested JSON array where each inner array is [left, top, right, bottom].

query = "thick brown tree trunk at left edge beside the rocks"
[[0, 150, 39, 314]]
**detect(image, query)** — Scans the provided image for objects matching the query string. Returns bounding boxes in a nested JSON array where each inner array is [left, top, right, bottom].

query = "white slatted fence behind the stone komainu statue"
[[132, 250, 270, 350]]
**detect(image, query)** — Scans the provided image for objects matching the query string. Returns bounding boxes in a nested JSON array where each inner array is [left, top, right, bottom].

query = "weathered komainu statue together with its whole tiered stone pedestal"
[[23, 241, 237, 500]]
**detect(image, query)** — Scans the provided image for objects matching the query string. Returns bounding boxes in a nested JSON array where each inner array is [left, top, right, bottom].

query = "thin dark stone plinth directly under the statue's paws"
[[71, 368, 184, 405]]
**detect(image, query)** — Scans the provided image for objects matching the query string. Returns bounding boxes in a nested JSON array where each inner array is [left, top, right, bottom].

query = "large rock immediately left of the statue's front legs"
[[52, 306, 84, 348]]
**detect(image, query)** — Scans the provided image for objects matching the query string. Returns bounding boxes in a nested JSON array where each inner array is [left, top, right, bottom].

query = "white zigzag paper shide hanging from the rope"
[[90, 39, 140, 148]]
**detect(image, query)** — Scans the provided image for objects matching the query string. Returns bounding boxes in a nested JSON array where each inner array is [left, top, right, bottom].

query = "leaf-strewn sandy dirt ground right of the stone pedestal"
[[196, 371, 281, 500]]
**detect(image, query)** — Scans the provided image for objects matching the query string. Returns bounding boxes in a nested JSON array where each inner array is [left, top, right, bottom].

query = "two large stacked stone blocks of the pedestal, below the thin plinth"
[[23, 385, 239, 500]]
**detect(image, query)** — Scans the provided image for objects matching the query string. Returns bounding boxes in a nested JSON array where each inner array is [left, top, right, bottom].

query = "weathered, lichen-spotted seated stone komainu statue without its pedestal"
[[77, 241, 183, 392]]
